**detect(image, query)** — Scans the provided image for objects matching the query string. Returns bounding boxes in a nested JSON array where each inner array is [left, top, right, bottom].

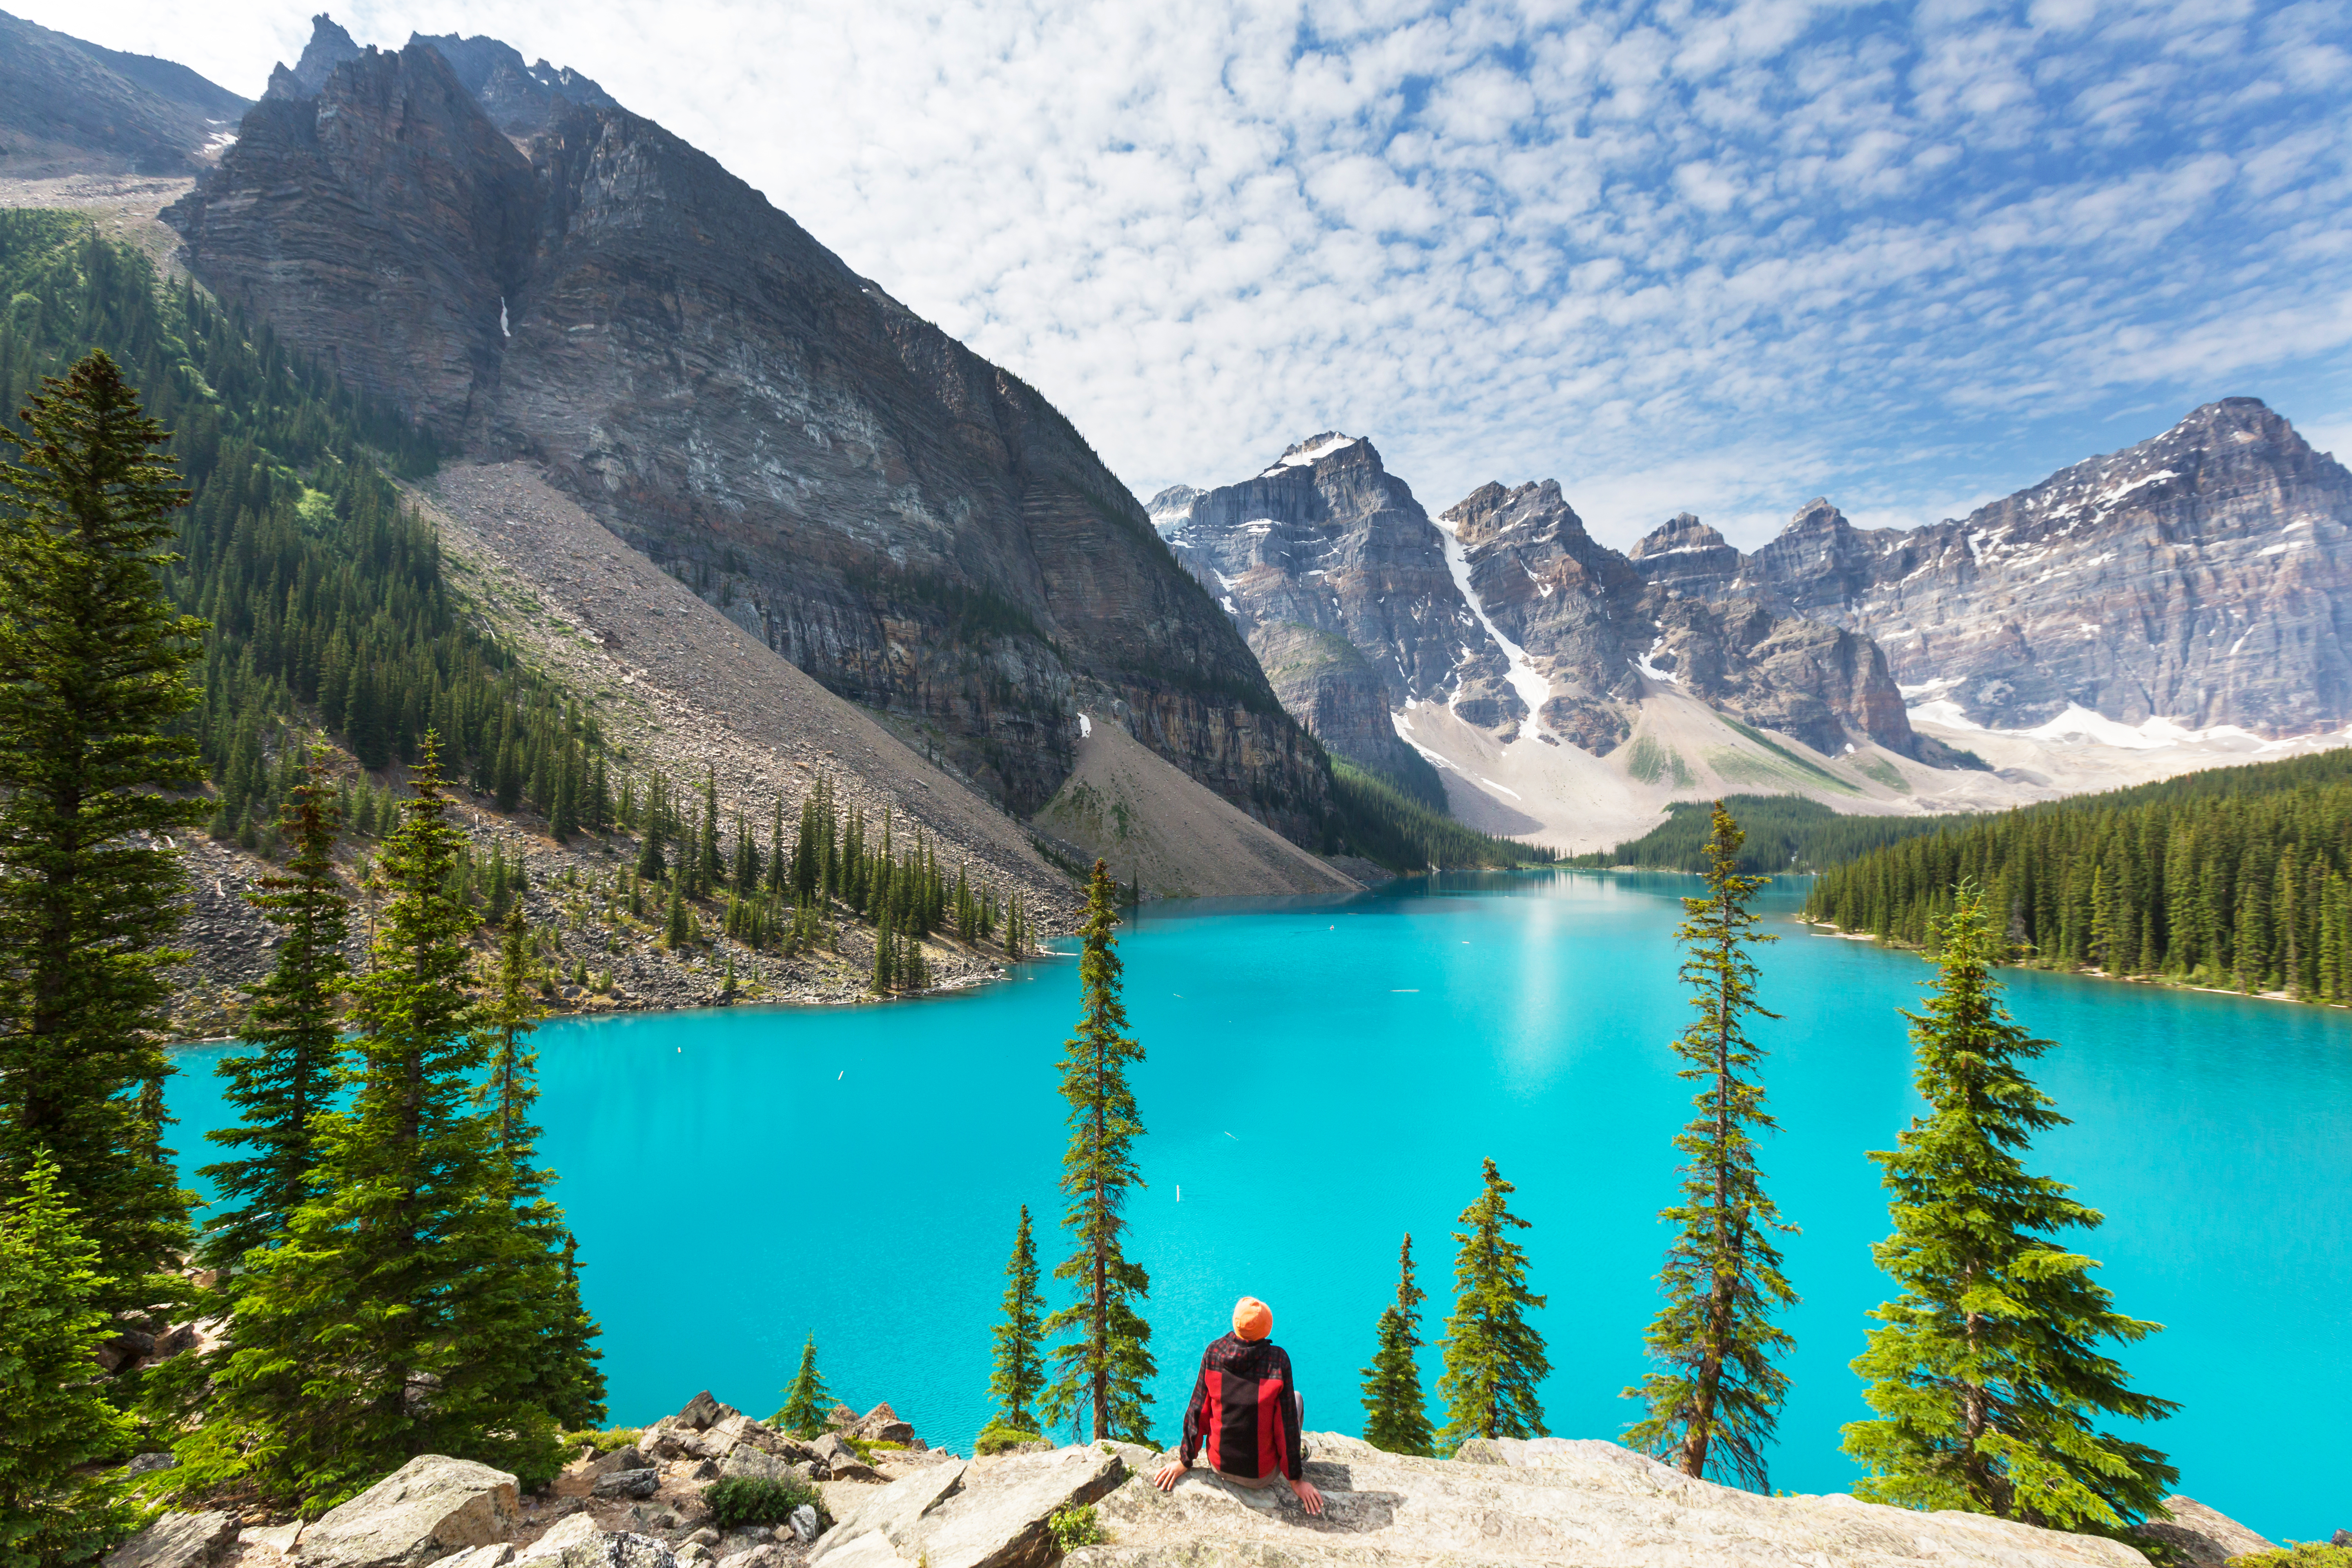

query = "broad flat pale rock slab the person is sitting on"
[[1063, 1432, 2147, 1568]]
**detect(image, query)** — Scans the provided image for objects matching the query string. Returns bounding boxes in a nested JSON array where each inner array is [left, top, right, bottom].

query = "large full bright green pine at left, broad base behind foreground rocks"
[[174, 733, 555, 1509]]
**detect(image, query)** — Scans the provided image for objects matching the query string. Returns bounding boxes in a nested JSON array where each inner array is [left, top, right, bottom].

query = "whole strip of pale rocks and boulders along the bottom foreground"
[[103, 1392, 2274, 1568]]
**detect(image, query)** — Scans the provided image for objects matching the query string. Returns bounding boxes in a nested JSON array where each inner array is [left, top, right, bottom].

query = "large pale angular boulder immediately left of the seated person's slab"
[[809, 1448, 1127, 1568]]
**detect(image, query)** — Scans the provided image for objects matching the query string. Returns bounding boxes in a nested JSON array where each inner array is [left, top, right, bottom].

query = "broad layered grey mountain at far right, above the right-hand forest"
[[1722, 397, 2352, 738]]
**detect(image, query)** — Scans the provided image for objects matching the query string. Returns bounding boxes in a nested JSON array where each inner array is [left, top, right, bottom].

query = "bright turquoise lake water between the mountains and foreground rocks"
[[172, 872, 2352, 1540]]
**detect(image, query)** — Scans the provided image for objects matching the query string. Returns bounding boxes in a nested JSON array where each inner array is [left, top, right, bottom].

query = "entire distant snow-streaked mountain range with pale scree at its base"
[[1150, 397, 2352, 842]]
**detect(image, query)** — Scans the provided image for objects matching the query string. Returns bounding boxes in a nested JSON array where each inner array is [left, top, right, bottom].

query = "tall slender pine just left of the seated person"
[[1044, 860, 1157, 1443]]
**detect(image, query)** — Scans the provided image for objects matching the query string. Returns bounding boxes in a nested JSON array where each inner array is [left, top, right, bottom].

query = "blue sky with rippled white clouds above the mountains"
[[12, 0, 2352, 546]]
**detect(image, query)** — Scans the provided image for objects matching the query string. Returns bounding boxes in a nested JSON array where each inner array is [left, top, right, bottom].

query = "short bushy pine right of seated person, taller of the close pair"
[[1437, 1159, 1552, 1450]]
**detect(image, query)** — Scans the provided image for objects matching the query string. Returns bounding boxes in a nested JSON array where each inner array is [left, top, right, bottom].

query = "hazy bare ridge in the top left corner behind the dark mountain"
[[0, 12, 247, 179]]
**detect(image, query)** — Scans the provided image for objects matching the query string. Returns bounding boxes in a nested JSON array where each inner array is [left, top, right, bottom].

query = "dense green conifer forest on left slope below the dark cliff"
[[0, 212, 602, 849]]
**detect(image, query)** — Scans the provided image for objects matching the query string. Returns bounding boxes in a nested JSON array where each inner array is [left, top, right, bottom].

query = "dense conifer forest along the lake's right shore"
[[1804, 752, 2352, 1002]]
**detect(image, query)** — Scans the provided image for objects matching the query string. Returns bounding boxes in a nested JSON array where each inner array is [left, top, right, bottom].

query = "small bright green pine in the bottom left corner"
[[0, 1154, 139, 1568]]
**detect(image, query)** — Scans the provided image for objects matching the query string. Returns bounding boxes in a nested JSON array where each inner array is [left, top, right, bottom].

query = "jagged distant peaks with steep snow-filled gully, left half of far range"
[[1152, 435, 1945, 771]]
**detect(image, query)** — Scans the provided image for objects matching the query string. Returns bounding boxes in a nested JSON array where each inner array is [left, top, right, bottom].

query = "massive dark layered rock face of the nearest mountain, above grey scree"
[[167, 19, 1329, 839]]
